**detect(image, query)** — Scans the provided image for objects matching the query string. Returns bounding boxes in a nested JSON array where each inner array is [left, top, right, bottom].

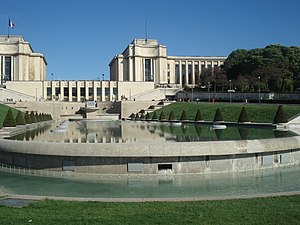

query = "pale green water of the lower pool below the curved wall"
[[0, 167, 300, 198]]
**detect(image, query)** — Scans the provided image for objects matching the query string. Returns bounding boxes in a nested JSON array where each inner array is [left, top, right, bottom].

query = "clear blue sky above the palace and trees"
[[0, 0, 300, 80]]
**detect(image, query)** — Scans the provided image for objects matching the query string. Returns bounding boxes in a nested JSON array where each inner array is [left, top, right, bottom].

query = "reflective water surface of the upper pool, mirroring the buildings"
[[5, 121, 295, 143]]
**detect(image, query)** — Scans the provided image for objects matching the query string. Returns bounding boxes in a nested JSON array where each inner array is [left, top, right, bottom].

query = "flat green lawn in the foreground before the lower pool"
[[0, 195, 300, 225]]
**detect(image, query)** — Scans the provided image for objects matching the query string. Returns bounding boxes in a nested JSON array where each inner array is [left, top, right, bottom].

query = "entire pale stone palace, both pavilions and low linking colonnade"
[[0, 36, 226, 102]]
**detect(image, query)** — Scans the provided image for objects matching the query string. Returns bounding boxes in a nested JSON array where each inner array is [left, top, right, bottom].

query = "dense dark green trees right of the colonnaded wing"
[[198, 44, 300, 92]]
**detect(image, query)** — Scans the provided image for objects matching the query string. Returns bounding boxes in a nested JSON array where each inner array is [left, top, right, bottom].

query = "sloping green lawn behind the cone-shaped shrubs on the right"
[[152, 102, 300, 123]]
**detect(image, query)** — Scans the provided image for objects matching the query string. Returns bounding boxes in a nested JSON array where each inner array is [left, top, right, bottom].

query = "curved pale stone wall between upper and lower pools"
[[0, 136, 300, 174]]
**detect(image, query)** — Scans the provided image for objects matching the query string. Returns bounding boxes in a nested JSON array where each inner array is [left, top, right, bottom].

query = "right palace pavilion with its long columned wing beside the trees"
[[109, 39, 227, 88]]
